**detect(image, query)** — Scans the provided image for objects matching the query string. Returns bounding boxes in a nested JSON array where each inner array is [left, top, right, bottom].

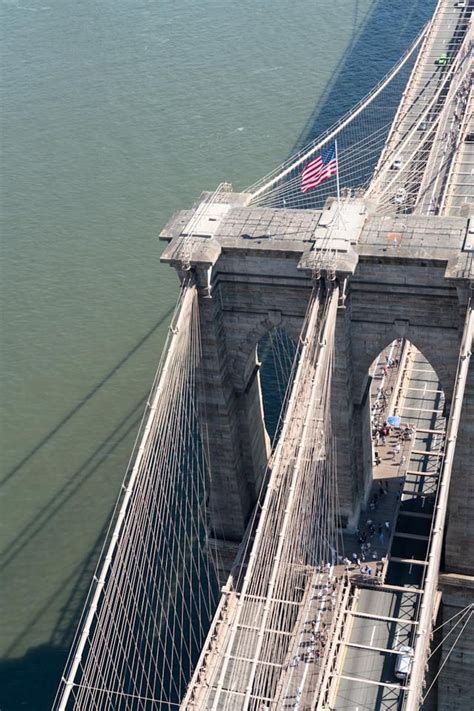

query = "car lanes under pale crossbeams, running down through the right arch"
[[329, 352, 444, 711]]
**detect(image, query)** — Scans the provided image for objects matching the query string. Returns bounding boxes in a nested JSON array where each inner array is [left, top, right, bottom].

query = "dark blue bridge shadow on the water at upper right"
[[290, 0, 436, 155]]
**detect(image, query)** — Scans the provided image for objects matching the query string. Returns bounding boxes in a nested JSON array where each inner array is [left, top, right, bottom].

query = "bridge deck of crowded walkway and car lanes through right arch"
[[201, 343, 444, 711]]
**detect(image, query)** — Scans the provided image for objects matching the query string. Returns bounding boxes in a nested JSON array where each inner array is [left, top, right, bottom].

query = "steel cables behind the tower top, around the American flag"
[[245, 3, 472, 215]]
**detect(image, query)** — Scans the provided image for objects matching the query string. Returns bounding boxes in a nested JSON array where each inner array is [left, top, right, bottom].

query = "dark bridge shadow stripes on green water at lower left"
[[0, 306, 174, 711]]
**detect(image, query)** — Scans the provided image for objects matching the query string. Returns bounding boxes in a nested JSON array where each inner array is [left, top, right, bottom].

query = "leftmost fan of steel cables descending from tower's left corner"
[[55, 283, 217, 711]]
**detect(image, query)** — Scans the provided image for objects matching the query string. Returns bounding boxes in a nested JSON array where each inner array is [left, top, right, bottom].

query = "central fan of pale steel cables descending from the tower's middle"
[[189, 282, 341, 711]]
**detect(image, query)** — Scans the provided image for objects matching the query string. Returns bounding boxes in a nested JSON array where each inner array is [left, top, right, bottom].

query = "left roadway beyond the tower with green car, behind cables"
[[372, 0, 474, 213]]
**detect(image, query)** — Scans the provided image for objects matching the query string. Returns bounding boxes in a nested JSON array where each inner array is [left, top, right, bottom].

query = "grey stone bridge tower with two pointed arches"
[[161, 191, 474, 574]]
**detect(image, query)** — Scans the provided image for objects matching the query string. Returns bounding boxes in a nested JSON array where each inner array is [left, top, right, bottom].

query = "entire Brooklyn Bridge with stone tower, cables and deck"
[[54, 0, 474, 711]]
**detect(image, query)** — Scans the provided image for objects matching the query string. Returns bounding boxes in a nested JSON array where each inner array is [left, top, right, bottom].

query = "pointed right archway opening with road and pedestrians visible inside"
[[355, 338, 446, 587]]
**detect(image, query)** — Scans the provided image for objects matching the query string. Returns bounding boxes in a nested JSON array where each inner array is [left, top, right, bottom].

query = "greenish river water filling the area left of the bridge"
[[0, 0, 435, 711]]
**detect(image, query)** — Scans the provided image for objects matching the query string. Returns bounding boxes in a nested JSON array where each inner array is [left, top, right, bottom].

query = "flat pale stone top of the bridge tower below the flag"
[[160, 192, 474, 282]]
